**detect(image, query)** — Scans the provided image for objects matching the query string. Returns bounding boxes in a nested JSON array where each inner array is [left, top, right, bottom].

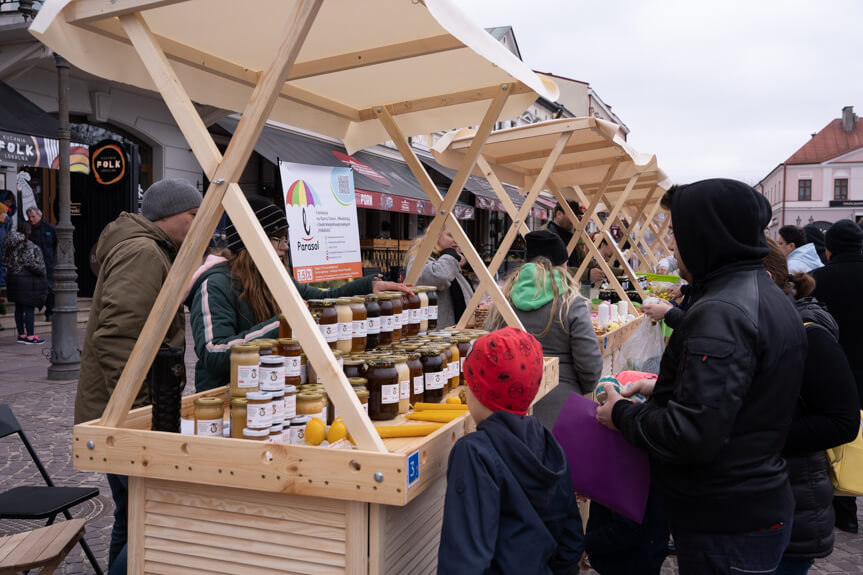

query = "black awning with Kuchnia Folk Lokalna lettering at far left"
[[0, 82, 90, 174]]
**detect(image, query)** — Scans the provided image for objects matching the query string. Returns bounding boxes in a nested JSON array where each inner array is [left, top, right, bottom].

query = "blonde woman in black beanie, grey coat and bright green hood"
[[486, 230, 602, 429]]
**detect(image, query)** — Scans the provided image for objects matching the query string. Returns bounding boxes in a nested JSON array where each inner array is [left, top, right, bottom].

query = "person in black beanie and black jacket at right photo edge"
[[812, 220, 863, 533]]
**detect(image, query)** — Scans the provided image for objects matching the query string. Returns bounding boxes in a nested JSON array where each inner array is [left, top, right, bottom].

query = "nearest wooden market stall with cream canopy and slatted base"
[[31, 0, 557, 574]]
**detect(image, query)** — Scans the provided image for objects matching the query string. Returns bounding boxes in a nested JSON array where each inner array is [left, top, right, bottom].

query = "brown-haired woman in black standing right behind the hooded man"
[[764, 236, 860, 575]]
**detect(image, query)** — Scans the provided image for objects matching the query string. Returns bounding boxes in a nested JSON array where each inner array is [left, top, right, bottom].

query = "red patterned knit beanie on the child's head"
[[464, 327, 542, 415]]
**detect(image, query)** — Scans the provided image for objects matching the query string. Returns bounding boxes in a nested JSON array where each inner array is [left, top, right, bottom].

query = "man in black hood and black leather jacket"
[[597, 179, 806, 575]]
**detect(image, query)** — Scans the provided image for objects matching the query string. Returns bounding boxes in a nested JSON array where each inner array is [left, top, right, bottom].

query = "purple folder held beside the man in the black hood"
[[553, 393, 650, 523]]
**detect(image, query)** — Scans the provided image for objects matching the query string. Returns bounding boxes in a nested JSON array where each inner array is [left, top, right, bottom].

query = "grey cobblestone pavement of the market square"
[[0, 322, 863, 575]]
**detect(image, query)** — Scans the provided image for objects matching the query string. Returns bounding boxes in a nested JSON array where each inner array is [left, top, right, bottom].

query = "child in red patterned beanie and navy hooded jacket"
[[438, 327, 584, 575]]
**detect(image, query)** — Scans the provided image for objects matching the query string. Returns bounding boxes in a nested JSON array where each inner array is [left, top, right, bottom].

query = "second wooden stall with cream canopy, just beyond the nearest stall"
[[432, 118, 671, 362]]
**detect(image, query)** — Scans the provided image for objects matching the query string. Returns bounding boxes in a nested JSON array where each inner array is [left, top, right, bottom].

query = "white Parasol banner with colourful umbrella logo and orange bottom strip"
[[279, 162, 363, 283]]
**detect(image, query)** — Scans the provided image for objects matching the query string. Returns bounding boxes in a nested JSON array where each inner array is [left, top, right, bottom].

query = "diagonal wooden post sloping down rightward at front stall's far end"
[[376, 106, 524, 329]]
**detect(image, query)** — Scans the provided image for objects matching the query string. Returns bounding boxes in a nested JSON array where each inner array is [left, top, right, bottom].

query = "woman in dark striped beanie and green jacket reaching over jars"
[[186, 196, 409, 392]]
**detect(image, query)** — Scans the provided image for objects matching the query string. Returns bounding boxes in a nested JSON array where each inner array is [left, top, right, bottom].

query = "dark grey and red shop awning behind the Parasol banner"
[[217, 118, 478, 219]]
